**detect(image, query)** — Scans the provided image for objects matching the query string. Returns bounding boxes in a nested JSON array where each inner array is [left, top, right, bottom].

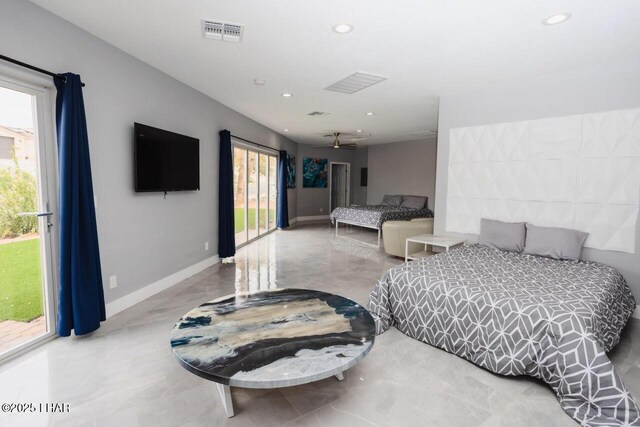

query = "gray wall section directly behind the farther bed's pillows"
[[367, 138, 437, 209]]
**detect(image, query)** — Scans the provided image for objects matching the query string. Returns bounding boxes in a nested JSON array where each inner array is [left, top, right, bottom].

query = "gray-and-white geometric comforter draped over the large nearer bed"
[[369, 245, 640, 426]]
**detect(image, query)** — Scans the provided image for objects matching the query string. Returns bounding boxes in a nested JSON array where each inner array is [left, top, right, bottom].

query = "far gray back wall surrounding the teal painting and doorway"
[[296, 144, 357, 217]]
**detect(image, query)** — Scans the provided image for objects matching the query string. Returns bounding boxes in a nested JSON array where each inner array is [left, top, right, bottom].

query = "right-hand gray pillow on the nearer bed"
[[524, 224, 589, 261]]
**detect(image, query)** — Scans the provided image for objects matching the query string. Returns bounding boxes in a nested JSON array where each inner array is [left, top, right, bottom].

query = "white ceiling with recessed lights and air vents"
[[32, 0, 640, 144]]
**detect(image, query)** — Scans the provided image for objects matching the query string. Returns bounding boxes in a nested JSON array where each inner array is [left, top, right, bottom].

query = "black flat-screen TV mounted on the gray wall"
[[134, 123, 200, 192]]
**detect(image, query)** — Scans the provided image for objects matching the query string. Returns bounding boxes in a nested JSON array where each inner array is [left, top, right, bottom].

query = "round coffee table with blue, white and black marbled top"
[[171, 289, 375, 417]]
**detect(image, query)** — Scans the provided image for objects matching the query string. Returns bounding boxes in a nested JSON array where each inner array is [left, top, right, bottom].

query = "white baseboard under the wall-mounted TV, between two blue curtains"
[[106, 255, 220, 318]]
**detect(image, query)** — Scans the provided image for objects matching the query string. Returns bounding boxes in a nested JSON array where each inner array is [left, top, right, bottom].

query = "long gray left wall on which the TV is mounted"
[[0, 0, 298, 302]]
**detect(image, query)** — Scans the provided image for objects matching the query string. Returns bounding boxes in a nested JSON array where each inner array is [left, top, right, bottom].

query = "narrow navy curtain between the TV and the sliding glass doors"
[[218, 129, 236, 258]]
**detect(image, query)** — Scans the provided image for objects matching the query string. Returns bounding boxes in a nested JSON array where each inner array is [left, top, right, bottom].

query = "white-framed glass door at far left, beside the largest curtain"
[[0, 80, 55, 359]]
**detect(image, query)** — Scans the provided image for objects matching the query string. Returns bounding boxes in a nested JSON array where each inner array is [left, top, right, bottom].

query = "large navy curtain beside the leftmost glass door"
[[55, 73, 105, 336]]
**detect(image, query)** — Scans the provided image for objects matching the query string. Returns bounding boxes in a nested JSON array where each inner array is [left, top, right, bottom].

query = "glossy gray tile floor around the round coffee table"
[[0, 225, 640, 427]]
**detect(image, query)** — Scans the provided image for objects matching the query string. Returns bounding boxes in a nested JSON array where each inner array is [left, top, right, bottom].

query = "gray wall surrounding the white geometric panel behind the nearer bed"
[[436, 60, 640, 299]]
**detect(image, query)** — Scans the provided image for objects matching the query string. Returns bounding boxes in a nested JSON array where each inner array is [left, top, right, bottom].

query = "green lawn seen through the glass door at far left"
[[0, 239, 44, 322]]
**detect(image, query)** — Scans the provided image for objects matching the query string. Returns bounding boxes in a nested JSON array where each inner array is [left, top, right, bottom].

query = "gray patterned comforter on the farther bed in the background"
[[329, 205, 433, 230]]
